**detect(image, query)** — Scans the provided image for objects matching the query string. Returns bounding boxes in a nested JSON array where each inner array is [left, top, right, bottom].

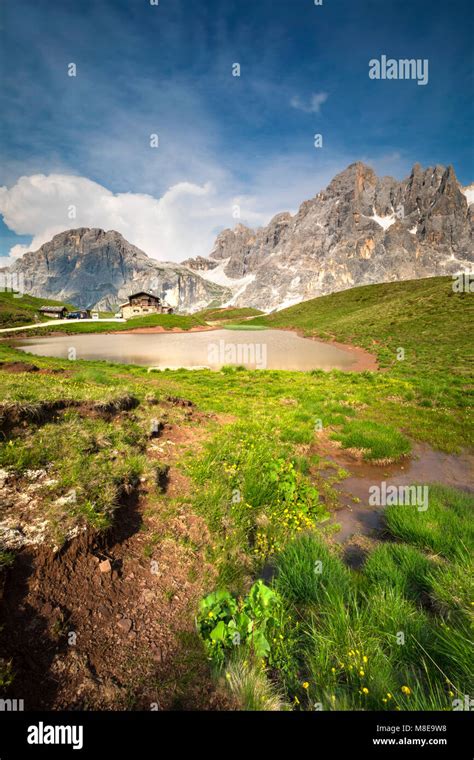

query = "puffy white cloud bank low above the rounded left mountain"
[[0, 174, 267, 261]]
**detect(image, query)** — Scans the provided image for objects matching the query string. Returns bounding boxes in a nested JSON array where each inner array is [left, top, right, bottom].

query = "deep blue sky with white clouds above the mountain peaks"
[[0, 0, 474, 260]]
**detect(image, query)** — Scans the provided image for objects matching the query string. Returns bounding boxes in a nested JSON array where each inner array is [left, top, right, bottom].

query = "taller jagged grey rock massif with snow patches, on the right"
[[187, 163, 474, 310]]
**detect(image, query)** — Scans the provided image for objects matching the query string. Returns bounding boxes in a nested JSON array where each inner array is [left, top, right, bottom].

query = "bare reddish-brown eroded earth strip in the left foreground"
[[0, 411, 231, 710]]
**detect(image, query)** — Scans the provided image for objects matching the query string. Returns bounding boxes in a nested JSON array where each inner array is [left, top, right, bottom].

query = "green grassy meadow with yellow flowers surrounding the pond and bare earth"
[[0, 278, 474, 710]]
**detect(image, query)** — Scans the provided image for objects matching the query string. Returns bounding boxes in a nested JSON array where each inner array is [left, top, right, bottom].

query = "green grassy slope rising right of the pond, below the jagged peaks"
[[250, 277, 474, 374]]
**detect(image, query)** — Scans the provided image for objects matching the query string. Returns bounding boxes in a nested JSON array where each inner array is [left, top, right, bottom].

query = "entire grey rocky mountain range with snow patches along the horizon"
[[10, 162, 474, 311]]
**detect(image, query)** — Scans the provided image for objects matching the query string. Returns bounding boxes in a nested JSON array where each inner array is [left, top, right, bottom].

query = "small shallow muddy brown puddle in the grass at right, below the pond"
[[324, 443, 474, 543]]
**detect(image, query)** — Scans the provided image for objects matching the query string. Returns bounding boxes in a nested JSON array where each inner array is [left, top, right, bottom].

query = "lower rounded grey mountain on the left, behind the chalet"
[[11, 228, 230, 311]]
